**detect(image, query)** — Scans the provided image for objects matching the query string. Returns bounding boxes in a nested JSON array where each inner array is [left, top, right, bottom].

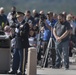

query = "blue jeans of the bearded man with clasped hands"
[[55, 41, 69, 68]]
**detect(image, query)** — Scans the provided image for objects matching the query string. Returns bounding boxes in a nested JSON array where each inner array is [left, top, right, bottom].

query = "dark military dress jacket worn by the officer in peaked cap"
[[15, 20, 29, 48]]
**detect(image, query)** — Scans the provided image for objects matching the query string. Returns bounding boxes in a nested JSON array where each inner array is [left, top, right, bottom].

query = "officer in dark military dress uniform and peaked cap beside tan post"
[[10, 12, 29, 75]]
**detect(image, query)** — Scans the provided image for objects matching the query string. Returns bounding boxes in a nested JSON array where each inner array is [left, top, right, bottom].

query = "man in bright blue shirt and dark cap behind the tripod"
[[43, 12, 56, 67]]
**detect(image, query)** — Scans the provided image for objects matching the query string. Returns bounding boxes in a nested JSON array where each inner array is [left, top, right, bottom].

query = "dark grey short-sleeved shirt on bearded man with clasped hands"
[[55, 21, 71, 42]]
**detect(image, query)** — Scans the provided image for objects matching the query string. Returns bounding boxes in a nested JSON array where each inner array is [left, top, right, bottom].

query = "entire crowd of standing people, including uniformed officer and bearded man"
[[0, 6, 76, 75]]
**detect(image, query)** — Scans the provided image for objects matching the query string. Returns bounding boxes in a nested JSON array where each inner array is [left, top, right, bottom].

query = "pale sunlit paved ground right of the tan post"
[[37, 65, 76, 75]]
